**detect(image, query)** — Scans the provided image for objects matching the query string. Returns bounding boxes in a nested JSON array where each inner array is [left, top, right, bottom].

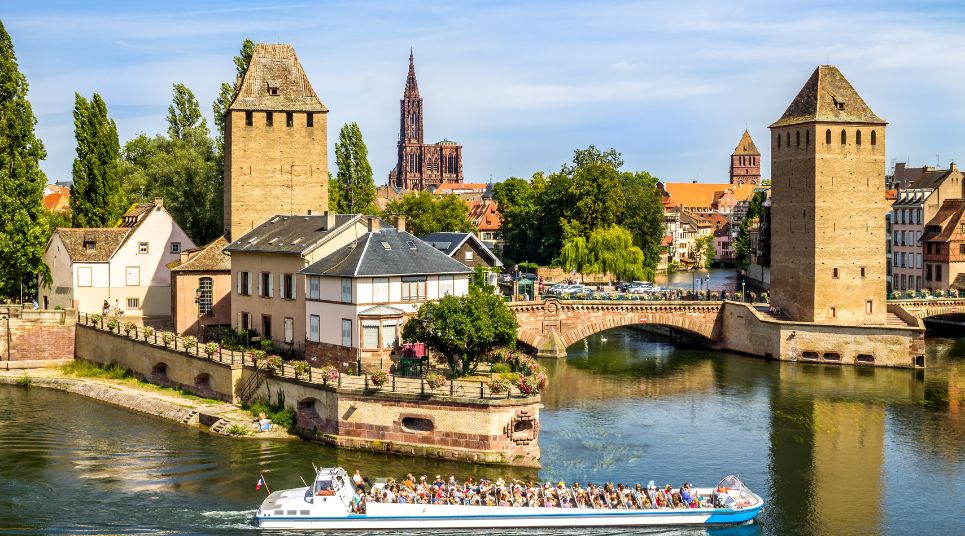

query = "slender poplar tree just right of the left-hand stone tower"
[[328, 122, 375, 214]]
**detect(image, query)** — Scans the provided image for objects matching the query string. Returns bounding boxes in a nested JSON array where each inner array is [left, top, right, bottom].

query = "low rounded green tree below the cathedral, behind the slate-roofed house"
[[382, 190, 473, 236]]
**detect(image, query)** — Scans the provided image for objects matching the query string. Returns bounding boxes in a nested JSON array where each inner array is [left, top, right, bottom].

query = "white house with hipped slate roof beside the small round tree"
[[299, 226, 472, 368]]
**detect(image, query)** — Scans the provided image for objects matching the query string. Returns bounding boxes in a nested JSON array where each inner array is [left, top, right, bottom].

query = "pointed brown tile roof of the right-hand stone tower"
[[770, 65, 887, 128]]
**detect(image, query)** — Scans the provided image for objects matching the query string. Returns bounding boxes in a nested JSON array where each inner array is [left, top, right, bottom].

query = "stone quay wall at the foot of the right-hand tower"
[[720, 302, 925, 368]]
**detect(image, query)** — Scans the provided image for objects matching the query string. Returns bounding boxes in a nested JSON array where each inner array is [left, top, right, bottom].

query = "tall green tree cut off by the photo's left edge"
[[0, 22, 49, 298]]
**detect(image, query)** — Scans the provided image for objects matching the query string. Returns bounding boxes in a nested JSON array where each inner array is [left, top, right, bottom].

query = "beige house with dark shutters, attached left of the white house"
[[224, 212, 379, 352]]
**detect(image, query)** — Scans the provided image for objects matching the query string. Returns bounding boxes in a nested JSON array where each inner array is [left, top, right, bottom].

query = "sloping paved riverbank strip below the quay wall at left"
[[0, 368, 298, 439]]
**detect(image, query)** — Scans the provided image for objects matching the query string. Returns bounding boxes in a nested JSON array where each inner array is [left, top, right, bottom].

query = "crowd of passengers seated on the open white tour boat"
[[353, 474, 723, 513]]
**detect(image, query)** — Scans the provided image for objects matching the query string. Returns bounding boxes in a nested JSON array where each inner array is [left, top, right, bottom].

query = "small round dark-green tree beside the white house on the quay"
[[402, 288, 519, 377]]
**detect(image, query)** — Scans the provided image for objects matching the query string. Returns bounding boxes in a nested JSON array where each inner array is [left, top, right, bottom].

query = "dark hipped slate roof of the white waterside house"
[[299, 226, 472, 277]]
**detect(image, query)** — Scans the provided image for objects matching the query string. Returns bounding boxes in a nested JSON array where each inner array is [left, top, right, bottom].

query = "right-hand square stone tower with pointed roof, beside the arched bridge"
[[770, 65, 888, 325]]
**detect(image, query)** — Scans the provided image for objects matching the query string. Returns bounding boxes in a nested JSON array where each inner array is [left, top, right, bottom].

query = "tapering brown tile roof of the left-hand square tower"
[[228, 43, 328, 112]]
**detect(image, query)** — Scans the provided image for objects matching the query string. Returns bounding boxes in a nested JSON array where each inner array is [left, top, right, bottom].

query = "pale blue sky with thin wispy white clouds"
[[0, 0, 965, 184]]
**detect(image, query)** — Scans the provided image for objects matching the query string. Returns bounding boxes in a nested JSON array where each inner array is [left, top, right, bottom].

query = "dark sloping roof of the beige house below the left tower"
[[224, 214, 362, 255]]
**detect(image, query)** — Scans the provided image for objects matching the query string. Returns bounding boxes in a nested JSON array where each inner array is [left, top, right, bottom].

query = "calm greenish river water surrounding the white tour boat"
[[0, 328, 965, 535]]
